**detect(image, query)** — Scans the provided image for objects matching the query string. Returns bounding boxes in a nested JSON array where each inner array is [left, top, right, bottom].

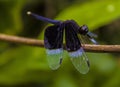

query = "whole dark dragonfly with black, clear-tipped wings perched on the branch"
[[27, 11, 97, 74]]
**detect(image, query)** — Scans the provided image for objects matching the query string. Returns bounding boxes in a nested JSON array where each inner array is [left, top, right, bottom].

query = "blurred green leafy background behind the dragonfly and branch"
[[0, 0, 120, 87]]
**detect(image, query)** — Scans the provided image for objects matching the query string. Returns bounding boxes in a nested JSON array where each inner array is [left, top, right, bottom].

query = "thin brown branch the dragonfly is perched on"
[[0, 34, 120, 53]]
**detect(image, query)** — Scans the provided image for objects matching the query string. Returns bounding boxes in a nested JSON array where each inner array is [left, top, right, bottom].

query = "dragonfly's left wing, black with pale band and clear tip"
[[44, 24, 64, 70]]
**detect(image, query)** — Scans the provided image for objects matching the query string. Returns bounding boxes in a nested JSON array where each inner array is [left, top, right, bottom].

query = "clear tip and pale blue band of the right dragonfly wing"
[[69, 47, 90, 74]]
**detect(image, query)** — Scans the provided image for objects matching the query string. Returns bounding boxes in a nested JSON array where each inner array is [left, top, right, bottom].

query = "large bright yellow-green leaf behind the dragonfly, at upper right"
[[56, 0, 120, 30]]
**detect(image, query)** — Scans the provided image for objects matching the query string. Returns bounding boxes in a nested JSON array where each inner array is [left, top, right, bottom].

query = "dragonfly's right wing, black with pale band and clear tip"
[[65, 21, 89, 74]]
